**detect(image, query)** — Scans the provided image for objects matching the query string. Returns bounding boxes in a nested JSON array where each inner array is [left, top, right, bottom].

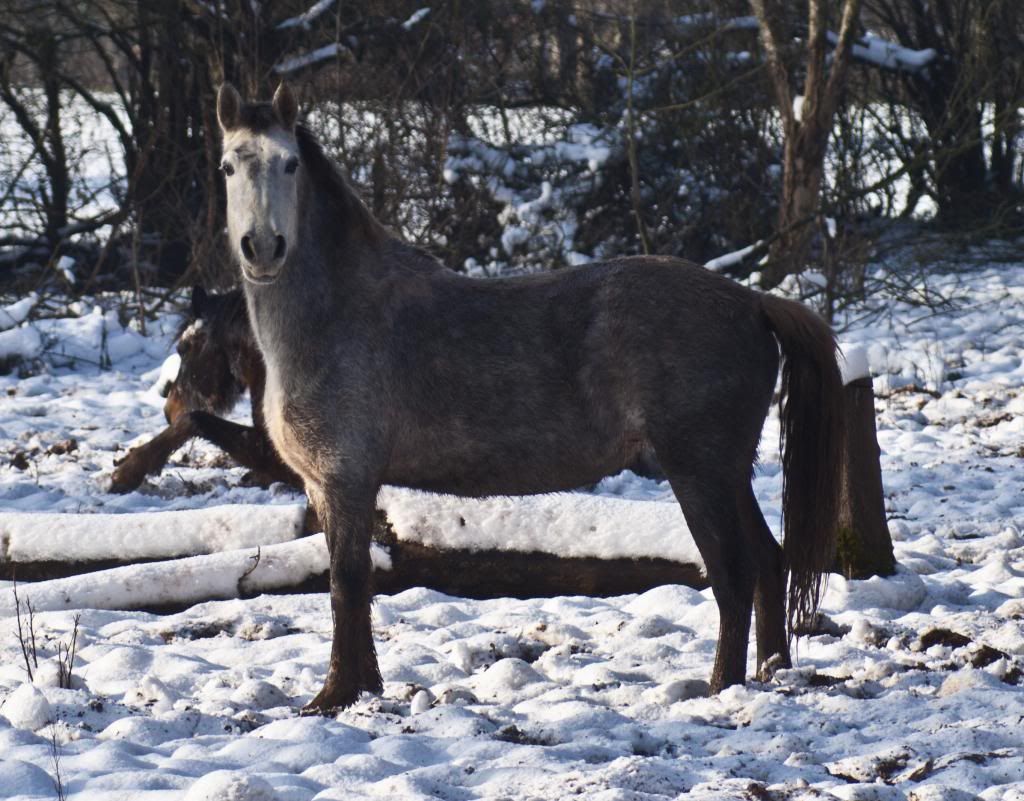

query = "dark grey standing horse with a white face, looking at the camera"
[[217, 86, 842, 712]]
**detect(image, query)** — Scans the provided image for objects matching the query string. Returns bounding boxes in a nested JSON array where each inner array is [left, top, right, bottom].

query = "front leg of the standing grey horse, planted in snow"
[[303, 480, 383, 715]]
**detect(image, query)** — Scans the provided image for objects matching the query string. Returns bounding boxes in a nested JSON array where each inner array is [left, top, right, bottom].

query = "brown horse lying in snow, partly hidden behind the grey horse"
[[110, 287, 302, 493]]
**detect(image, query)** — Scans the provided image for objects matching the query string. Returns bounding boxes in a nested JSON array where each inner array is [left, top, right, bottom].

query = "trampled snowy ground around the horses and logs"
[[0, 253, 1024, 801]]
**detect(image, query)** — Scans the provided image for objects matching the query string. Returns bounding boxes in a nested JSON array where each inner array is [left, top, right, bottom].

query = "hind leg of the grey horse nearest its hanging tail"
[[739, 487, 793, 680]]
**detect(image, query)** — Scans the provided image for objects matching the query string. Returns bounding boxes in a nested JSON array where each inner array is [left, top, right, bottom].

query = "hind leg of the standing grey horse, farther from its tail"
[[663, 473, 756, 694]]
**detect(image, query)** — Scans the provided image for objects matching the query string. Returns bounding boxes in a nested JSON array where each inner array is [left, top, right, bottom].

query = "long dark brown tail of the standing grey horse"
[[761, 295, 844, 633]]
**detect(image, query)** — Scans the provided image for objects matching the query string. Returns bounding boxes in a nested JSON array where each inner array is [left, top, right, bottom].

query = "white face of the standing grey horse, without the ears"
[[221, 127, 299, 275]]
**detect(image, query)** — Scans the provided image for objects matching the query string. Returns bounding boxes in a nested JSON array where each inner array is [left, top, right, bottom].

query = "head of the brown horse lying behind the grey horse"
[[164, 287, 252, 423]]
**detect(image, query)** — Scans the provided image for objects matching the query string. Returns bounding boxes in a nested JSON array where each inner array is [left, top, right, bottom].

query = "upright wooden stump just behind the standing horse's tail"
[[836, 377, 896, 579]]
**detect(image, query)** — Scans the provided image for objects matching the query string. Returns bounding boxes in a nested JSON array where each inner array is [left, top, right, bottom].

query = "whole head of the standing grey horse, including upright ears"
[[217, 84, 300, 284]]
